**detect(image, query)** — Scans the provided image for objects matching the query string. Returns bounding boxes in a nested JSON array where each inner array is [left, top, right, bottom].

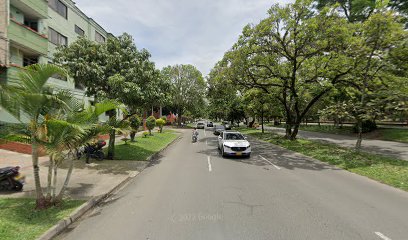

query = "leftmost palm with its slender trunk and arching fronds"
[[0, 64, 70, 208]]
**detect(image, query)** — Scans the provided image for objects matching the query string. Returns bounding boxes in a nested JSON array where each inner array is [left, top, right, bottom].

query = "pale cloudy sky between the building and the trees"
[[75, 0, 293, 75]]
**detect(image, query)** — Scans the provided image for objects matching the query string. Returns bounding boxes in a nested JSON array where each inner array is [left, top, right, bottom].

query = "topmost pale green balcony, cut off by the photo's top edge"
[[10, 0, 48, 19]]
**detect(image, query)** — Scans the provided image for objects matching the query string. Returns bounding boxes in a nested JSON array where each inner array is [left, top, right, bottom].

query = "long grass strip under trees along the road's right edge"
[[239, 128, 408, 191]]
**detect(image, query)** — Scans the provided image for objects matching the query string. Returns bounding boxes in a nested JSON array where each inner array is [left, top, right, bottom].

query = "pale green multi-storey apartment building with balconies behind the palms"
[[0, 0, 113, 122]]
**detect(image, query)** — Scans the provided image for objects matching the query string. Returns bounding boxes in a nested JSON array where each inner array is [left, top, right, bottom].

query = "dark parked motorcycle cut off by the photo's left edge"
[[0, 166, 25, 191]]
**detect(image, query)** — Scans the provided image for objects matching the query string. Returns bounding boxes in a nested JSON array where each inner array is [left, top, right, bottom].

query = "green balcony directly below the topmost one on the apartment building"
[[8, 19, 48, 55]]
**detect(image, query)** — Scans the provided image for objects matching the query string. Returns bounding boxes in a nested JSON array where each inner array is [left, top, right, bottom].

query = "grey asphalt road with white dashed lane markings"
[[58, 130, 408, 240]]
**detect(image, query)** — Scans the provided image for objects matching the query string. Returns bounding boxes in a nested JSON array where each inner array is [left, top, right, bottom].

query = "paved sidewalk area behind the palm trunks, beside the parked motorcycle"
[[0, 143, 148, 200]]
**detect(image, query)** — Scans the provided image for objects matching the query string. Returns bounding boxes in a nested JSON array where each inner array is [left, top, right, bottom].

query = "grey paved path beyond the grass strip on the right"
[[265, 126, 408, 161]]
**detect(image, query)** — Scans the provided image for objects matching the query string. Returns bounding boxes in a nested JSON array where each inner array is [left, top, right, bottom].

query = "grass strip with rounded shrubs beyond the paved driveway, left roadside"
[[110, 130, 178, 161]]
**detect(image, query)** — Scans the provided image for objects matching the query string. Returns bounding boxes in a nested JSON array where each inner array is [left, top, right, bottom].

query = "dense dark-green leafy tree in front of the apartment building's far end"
[[54, 33, 162, 159]]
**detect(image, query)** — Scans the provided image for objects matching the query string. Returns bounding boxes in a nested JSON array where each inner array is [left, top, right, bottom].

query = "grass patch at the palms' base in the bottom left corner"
[[0, 198, 84, 240]]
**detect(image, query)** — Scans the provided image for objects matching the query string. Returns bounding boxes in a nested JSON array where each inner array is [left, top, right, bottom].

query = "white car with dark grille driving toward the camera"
[[218, 131, 251, 157]]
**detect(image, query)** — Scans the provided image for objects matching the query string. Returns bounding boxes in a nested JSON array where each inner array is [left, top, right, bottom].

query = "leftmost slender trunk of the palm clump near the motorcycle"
[[31, 137, 46, 209]]
